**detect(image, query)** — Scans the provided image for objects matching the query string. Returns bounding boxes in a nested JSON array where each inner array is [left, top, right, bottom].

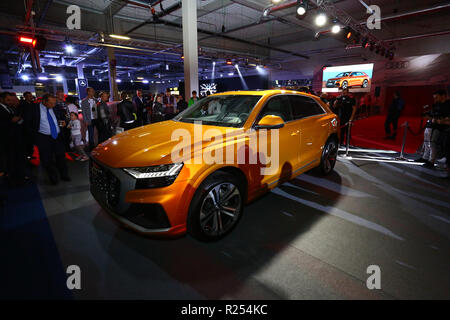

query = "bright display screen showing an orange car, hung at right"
[[322, 63, 373, 92]]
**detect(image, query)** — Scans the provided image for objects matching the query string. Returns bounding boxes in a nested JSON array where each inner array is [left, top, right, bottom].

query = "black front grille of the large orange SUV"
[[89, 160, 120, 208]]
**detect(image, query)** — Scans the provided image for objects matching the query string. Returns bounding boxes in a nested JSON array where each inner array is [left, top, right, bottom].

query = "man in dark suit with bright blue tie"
[[25, 94, 70, 185]]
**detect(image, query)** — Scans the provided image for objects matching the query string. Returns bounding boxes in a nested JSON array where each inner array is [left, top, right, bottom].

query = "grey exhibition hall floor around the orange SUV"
[[0, 155, 450, 299]]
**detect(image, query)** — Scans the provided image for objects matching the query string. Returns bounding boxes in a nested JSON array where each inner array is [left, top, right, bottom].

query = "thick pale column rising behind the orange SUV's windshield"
[[182, 0, 199, 101]]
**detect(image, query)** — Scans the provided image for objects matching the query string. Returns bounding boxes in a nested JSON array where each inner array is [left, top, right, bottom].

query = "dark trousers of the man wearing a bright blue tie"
[[37, 133, 69, 182]]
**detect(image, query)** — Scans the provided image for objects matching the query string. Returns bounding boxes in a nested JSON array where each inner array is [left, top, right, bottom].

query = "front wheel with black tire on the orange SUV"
[[187, 172, 244, 242]]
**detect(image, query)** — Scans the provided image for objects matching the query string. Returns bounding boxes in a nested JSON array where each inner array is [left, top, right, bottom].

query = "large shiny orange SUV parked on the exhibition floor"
[[89, 90, 339, 241]]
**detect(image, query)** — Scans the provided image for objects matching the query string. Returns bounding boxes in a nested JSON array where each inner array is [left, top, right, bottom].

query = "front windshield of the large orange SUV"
[[173, 95, 262, 128]]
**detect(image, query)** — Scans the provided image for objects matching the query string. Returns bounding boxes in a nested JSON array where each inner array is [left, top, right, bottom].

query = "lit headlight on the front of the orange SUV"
[[123, 163, 183, 189]]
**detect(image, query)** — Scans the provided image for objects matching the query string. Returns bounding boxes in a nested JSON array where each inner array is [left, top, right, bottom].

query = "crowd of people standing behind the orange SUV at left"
[[0, 88, 198, 187]]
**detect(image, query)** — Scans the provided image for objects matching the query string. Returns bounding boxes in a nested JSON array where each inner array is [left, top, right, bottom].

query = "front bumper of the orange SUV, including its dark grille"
[[89, 159, 187, 235]]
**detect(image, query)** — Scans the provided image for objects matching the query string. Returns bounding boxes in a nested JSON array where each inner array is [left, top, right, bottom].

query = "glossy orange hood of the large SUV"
[[92, 120, 244, 168]]
